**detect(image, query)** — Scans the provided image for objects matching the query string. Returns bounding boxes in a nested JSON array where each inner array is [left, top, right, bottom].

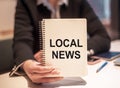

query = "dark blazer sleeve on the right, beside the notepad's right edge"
[[80, 0, 111, 54]]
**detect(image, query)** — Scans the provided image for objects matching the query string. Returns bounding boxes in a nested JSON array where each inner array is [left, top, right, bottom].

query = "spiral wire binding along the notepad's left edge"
[[39, 20, 45, 66]]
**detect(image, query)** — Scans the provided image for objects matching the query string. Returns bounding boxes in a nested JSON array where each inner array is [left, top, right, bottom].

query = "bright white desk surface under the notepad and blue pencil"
[[0, 40, 120, 88]]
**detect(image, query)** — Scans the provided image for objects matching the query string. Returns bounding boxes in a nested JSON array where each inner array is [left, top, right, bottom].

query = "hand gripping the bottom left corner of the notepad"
[[23, 60, 63, 83]]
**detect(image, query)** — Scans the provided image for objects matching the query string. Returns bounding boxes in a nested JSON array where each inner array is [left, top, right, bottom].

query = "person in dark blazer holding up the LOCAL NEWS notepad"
[[10, 0, 110, 83]]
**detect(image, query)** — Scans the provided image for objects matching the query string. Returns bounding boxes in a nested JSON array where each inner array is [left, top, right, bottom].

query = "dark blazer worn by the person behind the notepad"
[[13, 0, 110, 65]]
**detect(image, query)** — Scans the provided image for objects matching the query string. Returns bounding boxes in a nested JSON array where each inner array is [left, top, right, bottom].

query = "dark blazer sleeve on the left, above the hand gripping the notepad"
[[13, 0, 34, 65]]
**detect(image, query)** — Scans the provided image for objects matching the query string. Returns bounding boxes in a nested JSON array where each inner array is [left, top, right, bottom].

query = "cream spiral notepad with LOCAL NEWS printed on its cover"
[[40, 19, 87, 77]]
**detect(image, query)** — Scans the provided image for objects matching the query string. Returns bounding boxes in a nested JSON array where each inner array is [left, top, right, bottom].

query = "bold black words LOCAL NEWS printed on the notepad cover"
[[50, 39, 83, 59]]
